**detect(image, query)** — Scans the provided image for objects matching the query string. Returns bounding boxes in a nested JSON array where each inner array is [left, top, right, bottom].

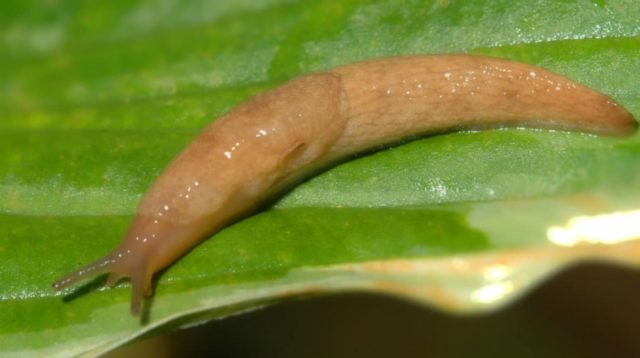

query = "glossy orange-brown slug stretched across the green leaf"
[[53, 55, 637, 314]]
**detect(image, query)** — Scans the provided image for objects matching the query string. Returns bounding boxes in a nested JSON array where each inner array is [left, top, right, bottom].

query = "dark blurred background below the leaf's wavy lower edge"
[[107, 263, 640, 357]]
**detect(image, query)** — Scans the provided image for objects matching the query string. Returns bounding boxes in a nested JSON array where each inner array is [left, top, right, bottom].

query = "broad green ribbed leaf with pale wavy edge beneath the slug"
[[0, 0, 640, 356]]
